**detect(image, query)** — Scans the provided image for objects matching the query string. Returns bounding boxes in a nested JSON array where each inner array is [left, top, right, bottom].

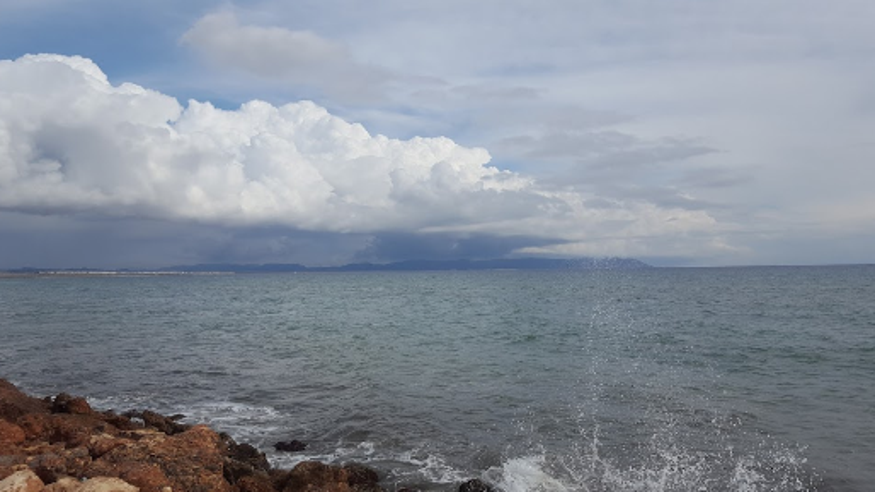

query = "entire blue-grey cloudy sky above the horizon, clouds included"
[[0, 0, 875, 268]]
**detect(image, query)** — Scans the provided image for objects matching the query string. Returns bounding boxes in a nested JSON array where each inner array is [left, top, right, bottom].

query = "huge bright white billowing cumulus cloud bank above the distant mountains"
[[0, 55, 717, 260]]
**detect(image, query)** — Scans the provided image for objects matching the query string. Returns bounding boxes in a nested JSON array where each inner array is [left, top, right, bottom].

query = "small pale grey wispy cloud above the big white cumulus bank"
[[180, 11, 391, 101]]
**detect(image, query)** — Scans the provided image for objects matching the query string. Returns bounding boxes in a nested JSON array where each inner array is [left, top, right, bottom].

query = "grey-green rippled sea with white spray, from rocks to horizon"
[[0, 266, 875, 492]]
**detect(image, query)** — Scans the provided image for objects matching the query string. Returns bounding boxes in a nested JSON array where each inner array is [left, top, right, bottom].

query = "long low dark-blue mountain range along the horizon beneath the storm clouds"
[[7, 258, 652, 275]]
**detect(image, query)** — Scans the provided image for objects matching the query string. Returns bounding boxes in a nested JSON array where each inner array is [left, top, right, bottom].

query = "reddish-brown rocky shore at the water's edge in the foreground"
[[0, 379, 491, 492]]
